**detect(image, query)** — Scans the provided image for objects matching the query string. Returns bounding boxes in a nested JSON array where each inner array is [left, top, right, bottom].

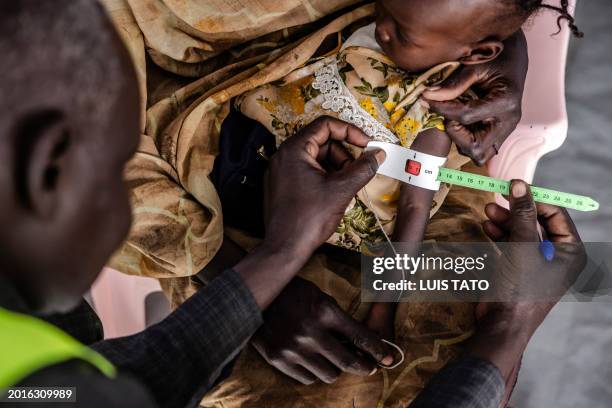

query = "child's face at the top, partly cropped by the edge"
[[376, 0, 510, 72]]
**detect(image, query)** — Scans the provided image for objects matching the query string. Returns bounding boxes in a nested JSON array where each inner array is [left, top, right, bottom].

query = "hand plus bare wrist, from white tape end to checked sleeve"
[[234, 117, 385, 309]]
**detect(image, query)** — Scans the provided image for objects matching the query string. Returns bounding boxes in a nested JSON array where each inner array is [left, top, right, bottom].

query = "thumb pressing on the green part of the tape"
[[509, 180, 539, 242]]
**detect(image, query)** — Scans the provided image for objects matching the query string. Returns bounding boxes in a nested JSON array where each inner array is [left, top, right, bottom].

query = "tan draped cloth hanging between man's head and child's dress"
[[104, 0, 374, 286]]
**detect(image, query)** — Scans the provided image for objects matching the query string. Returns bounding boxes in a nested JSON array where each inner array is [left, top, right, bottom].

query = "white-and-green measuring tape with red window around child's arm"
[[367, 142, 599, 211]]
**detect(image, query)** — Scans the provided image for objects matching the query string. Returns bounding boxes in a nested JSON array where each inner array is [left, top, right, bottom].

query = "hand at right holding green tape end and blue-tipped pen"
[[483, 180, 586, 312]]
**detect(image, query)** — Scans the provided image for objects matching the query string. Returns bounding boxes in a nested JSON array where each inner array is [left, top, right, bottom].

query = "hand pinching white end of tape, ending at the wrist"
[[264, 117, 385, 262]]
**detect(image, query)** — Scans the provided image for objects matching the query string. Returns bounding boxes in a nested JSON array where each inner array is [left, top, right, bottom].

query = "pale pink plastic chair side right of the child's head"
[[488, 0, 576, 205]]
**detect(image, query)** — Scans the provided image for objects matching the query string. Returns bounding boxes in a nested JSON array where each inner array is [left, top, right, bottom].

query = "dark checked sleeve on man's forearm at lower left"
[[93, 270, 263, 407]]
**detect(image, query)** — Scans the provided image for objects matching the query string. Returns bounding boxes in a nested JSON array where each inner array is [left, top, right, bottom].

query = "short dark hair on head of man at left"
[[0, 0, 128, 135]]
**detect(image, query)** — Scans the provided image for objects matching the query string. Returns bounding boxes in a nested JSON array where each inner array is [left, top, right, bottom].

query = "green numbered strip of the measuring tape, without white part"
[[438, 167, 599, 211]]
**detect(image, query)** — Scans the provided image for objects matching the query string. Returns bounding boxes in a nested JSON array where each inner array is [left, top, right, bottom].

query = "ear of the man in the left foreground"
[[14, 110, 72, 218]]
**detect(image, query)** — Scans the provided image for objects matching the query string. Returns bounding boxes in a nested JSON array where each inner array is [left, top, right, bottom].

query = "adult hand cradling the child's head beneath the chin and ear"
[[423, 31, 529, 166]]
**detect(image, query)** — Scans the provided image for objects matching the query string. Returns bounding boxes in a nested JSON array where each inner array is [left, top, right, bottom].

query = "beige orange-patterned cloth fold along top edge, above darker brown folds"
[[127, 0, 358, 77]]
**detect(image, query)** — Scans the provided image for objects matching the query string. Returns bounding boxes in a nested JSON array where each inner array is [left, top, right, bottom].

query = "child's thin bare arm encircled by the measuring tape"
[[367, 129, 451, 339]]
